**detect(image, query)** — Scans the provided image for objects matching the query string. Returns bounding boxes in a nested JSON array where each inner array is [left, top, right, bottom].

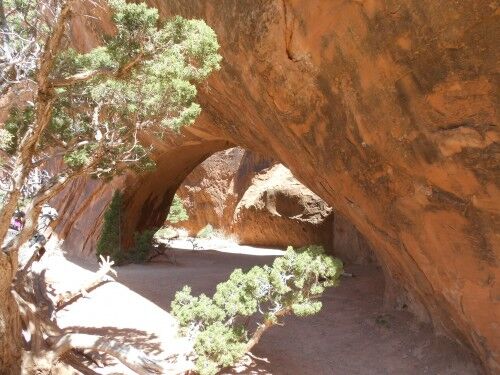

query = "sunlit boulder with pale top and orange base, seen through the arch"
[[232, 164, 332, 248]]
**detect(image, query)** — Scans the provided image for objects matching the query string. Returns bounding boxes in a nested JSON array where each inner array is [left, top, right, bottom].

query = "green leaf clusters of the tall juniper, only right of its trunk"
[[51, 0, 221, 177]]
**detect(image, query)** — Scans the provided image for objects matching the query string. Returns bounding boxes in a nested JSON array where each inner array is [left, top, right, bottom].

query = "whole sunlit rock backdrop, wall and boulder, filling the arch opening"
[[178, 148, 336, 248]]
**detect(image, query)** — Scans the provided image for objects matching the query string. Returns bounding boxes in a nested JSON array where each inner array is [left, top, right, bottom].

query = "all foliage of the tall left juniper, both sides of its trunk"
[[0, 0, 222, 178]]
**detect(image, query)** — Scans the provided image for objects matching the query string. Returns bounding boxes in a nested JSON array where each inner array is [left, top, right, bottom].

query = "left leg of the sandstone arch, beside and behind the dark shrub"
[[55, 128, 232, 254]]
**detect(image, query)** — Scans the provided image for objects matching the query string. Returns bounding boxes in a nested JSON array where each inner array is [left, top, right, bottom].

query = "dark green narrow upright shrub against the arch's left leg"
[[96, 190, 123, 263]]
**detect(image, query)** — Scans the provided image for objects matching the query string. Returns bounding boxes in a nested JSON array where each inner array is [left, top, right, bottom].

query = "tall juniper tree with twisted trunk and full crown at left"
[[0, 0, 221, 373]]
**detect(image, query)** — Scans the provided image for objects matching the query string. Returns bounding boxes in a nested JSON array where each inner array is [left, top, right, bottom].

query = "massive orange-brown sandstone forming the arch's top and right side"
[[51, 0, 500, 372]]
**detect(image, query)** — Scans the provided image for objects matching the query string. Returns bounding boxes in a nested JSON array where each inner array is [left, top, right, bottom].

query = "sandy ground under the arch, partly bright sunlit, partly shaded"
[[47, 244, 481, 375]]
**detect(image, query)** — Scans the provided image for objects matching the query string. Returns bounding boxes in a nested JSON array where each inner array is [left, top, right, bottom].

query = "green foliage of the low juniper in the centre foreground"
[[171, 246, 343, 375]]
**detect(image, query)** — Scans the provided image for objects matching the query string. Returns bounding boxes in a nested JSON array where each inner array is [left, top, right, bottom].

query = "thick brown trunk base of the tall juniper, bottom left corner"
[[0, 254, 22, 375]]
